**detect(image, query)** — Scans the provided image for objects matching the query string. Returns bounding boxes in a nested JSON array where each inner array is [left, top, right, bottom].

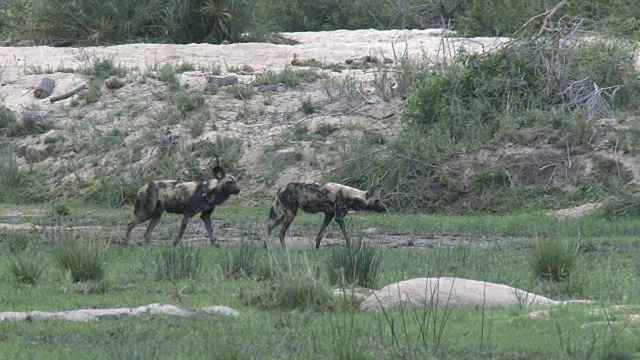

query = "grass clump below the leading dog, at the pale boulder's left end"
[[327, 239, 380, 288]]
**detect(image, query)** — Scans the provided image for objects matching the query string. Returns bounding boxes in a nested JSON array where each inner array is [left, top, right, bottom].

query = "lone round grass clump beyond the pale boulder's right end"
[[531, 239, 578, 282]]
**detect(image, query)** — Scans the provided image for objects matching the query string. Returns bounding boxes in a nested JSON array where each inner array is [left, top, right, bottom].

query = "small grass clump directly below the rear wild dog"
[[155, 246, 202, 281]]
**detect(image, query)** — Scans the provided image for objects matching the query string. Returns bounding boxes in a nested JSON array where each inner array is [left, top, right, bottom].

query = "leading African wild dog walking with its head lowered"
[[268, 182, 387, 249]]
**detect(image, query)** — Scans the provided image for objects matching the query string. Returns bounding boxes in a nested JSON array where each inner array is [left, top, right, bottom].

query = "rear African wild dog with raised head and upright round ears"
[[125, 166, 240, 245]]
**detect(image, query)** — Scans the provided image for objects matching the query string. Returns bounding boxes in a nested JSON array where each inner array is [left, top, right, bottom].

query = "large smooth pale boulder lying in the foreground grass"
[[360, 277, 583, 312]]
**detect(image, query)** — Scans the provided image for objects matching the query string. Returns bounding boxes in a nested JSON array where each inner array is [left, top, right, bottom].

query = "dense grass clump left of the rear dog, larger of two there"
[[54, 234, 105, 282]]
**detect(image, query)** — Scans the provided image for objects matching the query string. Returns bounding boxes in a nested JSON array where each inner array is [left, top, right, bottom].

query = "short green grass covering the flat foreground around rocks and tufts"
[[0, 199, 640, 359]]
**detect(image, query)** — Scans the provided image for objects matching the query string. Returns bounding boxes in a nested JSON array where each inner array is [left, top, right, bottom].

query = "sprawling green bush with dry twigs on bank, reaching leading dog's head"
[[327, 40, 640, 212]]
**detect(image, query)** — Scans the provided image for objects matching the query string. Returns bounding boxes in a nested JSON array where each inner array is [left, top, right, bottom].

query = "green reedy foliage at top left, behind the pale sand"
[[1, 0, 255, 44]]
